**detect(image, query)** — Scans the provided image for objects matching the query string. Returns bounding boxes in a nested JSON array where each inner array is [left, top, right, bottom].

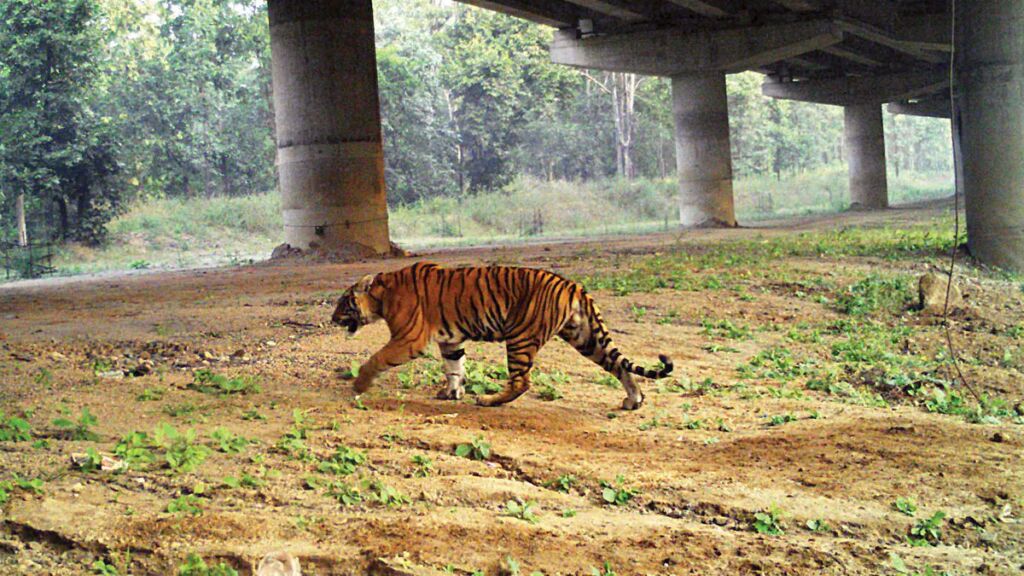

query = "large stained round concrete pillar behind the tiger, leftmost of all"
[[268, 0, 389, 253]]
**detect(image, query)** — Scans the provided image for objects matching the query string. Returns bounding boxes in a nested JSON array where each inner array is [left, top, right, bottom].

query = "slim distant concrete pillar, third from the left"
[[843, 104, 889, 210]]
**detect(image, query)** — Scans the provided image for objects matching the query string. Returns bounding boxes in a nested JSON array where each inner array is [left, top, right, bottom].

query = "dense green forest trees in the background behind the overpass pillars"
[[0, 0, 950, 243]]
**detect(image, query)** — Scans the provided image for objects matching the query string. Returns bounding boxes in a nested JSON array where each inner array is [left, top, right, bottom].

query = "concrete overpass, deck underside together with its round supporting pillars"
[[269, 0, 1024, 270]]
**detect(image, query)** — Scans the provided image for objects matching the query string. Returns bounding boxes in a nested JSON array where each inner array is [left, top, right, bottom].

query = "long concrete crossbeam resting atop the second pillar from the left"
[[551, 20, 843, 76]]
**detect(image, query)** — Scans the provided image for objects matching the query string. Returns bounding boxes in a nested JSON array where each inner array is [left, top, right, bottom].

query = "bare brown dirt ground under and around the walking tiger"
[[0, 202, 1024, 575]]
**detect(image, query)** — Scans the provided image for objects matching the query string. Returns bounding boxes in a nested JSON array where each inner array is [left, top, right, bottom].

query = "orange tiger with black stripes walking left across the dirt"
[[331, 261, 673, 410]]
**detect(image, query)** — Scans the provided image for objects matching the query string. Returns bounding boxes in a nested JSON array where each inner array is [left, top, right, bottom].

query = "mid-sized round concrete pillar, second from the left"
[[672, 73, 736, 228]]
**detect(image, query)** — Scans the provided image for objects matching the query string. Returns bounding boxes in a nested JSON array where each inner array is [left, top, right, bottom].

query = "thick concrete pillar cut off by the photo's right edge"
[[956, 0, 1024, 272]]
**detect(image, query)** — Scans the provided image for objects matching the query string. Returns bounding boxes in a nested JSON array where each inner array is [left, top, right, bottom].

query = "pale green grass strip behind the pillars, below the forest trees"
[[25, 166, 952, 275]]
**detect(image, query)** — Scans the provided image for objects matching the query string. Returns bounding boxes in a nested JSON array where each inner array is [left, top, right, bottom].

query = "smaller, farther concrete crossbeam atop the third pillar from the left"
[[761, 71, 949, 106]]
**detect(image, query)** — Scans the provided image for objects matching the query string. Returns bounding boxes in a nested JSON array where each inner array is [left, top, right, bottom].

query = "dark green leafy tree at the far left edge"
[[0, 0, 118, 242]]
